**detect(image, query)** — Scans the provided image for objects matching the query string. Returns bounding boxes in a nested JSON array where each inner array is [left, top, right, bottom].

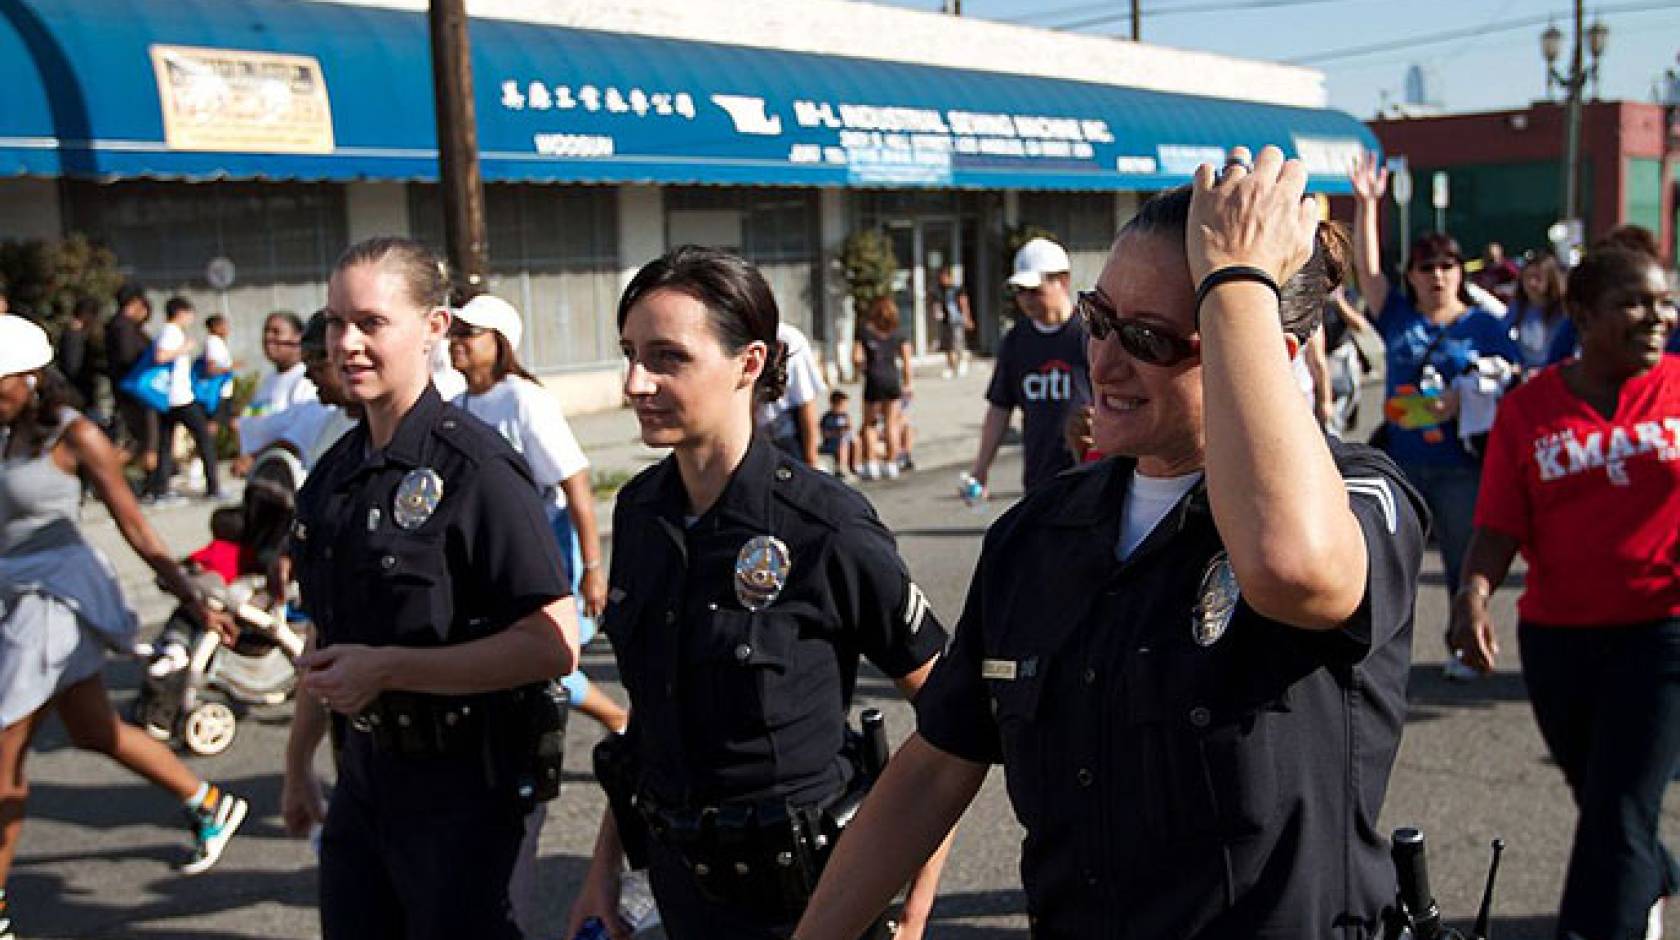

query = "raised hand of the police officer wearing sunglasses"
[[1184, 146, 1319, 284]]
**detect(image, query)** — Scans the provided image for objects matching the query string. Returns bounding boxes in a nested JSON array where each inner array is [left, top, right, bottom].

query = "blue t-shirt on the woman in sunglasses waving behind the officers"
[[1376, 287, 1522, 467]]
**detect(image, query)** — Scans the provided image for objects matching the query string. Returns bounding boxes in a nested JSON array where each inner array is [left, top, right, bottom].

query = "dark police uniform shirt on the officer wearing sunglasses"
[[916, 441, 1426, 940]]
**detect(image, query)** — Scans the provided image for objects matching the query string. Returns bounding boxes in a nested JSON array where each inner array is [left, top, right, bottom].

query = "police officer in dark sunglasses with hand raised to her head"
[[798, 148, 1425, 940]]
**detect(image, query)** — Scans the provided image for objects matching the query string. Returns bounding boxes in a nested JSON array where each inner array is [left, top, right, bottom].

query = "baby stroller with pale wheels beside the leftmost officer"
[[134, 448, 304, 757]]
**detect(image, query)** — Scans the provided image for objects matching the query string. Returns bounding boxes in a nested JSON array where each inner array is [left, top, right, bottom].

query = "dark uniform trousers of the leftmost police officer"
[[321, 732, 541, 940]]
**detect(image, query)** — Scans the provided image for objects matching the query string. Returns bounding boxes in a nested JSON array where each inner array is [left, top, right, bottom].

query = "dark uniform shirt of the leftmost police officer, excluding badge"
[[291, 384, 571, 646]]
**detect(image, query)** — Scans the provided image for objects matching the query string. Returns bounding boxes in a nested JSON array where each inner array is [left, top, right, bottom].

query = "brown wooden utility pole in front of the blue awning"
[[427, 0, 489, 294]]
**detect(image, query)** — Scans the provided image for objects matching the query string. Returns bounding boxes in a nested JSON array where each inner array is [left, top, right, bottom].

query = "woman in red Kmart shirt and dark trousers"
[[1448, 248, 1680, 940]]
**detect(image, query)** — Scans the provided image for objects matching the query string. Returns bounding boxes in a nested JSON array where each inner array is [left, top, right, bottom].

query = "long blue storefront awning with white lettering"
[[0, 0, 1378, 193]]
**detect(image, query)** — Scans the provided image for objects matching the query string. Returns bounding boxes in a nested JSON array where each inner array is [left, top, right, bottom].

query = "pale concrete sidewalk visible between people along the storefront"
[[82, 359, 994, 626]]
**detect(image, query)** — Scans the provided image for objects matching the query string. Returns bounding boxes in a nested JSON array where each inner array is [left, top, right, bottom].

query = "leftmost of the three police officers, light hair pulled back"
[[286, 238, 578, 940]]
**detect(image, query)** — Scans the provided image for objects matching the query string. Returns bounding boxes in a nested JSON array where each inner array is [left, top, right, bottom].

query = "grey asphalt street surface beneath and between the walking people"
[[8, 453, 1680, 940]]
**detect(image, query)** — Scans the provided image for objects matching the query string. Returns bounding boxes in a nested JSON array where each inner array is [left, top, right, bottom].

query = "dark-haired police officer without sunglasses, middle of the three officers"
[[571, 247, 946, 940]]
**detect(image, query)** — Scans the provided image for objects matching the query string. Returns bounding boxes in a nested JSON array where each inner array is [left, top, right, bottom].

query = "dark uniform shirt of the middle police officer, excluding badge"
[[603, 436, 946, 807]]
